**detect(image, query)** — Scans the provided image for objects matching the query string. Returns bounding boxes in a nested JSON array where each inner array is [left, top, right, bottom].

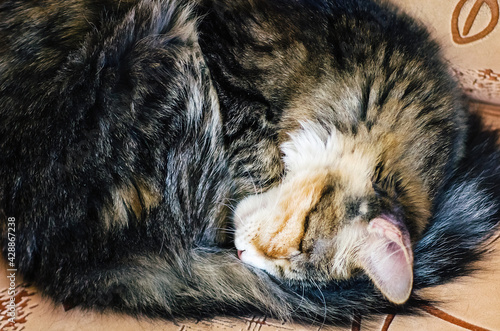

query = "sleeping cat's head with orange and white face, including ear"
[[234, 123, 428, 304]]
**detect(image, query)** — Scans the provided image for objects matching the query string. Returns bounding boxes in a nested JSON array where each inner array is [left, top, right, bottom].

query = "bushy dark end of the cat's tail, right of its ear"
[[414, 115, 500, 289]]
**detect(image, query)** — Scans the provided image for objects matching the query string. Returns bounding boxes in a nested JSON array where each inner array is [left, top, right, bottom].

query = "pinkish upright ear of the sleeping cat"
[[359, 216, 413, 304]]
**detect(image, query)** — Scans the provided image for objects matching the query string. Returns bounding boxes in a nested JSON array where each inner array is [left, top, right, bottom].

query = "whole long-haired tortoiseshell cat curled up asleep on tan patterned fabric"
[[0, 0, 500, 324]]
